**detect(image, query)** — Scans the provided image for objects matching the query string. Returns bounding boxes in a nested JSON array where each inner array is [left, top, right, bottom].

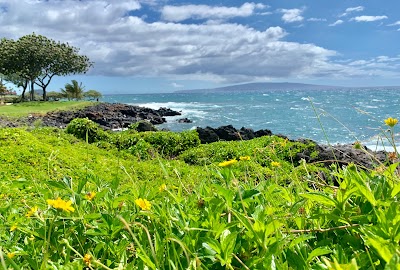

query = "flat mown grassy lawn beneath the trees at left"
[[0, 101, 93, 117]]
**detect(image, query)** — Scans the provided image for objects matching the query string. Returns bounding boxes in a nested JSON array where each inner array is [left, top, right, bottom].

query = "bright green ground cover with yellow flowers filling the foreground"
[[0, 119, 400, 269]]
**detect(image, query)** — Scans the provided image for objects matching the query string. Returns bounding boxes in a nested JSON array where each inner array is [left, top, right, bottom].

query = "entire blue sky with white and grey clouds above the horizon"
[[0, 0, 400, 94]]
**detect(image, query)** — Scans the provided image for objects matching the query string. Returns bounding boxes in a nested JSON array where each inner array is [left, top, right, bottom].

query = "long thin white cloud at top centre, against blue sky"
[[161, 3, 266, 22]]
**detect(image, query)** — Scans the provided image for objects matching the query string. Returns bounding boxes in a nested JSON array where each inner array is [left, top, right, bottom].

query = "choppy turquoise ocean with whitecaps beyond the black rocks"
[[102, 88, 400, 148]]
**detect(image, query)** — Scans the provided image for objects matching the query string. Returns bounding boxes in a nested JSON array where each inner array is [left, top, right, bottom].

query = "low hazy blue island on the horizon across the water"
[[175, 82, 400, 93]]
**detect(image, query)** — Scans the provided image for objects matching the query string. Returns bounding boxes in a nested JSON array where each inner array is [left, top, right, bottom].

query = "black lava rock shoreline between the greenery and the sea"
[[0, 103, 388, 168]]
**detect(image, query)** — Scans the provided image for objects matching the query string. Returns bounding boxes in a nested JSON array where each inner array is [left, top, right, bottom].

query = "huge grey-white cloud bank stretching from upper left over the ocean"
[[0, 0, 397, 84]]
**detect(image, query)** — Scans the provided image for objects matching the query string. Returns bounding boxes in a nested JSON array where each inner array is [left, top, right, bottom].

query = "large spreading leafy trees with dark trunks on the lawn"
[[0, 33, 92, 100]]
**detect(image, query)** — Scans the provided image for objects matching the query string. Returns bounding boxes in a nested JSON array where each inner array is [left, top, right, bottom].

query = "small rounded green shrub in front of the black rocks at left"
[[66, 118, 108, 143]]
